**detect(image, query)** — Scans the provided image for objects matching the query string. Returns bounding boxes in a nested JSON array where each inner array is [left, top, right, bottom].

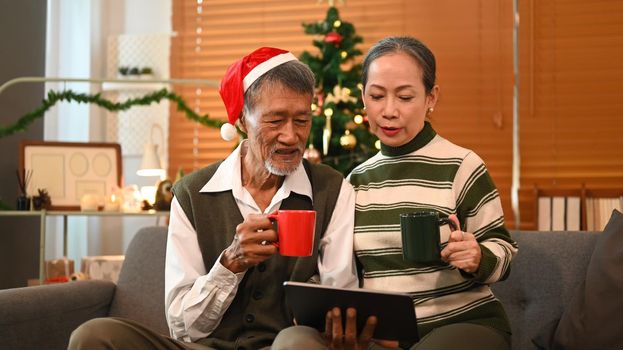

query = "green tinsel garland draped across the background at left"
[[0, 89, 225, 138]]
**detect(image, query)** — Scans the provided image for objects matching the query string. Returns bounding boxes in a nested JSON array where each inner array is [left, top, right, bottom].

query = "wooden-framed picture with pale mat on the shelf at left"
[[20, 141, 122, 210]]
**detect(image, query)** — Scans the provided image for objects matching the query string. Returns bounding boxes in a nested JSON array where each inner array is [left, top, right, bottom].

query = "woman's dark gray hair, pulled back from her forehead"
[[362, 36, 436, 94]]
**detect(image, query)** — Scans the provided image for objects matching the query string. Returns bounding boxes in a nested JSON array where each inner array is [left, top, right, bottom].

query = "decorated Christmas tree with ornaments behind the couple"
[[300, 5, 378, 175]]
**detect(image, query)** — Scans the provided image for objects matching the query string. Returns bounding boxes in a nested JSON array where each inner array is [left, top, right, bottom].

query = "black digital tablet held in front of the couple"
[[283, 281, 419, 342]]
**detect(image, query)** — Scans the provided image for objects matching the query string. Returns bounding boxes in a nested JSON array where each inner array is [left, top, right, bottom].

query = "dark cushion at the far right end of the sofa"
[[551, 210, 623, 350]]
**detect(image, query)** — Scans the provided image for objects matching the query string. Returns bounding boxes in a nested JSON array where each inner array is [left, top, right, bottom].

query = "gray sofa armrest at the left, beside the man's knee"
[[0, 280, 115, 349]]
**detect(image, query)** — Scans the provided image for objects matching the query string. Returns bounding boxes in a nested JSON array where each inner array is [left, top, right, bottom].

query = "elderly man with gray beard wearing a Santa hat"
[[70, 47, 357, 349]]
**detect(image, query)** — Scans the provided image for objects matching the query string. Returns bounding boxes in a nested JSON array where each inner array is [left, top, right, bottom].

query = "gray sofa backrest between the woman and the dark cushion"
[[492, 231, 599, 350]]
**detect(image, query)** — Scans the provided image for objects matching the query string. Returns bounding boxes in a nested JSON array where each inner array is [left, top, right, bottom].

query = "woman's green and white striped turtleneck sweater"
[[349, 122, 517, 336]]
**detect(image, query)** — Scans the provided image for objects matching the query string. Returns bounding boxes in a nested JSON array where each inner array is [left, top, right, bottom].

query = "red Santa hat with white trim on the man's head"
[[219, 47, 296, 141]]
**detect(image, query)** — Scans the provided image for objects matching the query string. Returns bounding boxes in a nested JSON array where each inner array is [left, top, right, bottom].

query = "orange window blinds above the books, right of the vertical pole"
[[519, 0, 623, 227]]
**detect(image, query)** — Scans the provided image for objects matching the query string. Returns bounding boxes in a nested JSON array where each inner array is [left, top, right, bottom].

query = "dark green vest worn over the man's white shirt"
[[173, 160, 344, 349]]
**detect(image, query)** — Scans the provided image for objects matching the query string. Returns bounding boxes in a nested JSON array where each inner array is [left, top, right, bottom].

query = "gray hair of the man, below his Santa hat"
[[242, 60, 315, 116]]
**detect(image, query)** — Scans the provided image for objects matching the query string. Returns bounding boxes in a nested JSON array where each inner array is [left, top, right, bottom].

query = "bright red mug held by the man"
[[268, 210, 316, 256]]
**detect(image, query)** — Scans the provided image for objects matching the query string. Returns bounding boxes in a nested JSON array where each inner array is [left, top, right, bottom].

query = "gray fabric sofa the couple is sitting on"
[[0, 227, 599, 350]]
